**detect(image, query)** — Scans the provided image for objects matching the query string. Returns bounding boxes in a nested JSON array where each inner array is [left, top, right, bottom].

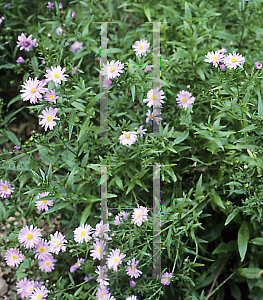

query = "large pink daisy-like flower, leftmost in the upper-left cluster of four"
[[20, 77, 47, 104]]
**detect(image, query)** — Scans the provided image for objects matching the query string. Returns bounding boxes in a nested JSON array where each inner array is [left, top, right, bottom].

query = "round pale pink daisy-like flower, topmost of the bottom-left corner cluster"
[[17, 225, 41, 249]]
